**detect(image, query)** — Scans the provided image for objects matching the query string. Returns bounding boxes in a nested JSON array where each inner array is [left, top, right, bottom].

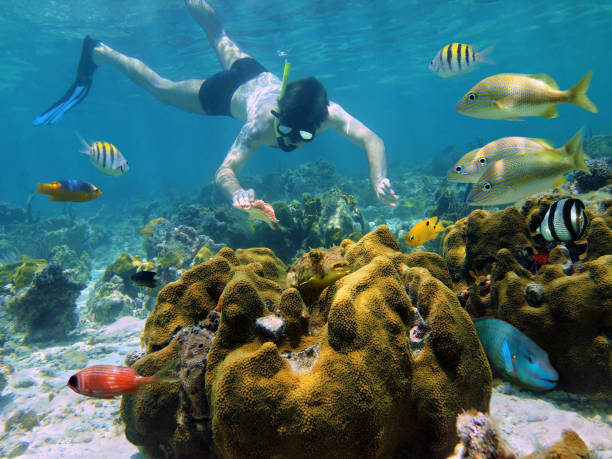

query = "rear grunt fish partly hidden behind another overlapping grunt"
[[448, 137, 554, 183]]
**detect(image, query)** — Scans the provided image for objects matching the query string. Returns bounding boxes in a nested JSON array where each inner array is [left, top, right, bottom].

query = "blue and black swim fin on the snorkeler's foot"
[[32, 35, 100, 126]]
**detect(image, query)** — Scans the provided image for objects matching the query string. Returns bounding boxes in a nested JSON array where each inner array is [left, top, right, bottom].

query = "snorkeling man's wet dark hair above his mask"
[[278, 77, 329, 128]]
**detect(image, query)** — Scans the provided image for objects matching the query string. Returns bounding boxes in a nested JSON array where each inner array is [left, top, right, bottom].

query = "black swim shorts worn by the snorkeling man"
[[199, 57, 267, 116]]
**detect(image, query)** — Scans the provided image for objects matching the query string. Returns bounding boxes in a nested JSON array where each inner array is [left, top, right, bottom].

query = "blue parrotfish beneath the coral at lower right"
[[474, 318, 559, 391]]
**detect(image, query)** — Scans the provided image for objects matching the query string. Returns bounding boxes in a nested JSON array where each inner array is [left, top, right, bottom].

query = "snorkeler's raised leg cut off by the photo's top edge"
[[185, 0, 251, 70]]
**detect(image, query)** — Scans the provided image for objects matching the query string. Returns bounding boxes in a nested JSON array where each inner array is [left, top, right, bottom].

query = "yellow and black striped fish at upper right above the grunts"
[[429, 43, 495, 78]]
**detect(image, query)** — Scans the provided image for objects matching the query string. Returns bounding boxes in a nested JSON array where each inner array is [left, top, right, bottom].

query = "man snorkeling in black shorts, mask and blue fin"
[[33, 0, 398, 210]]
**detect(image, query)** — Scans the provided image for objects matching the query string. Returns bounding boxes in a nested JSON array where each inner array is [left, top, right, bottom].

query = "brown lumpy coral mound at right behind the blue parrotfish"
[[443, 195, 612, 394]]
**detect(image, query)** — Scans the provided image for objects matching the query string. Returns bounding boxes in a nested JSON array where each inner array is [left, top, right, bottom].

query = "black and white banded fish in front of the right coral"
[[539, 199, 589, 241]]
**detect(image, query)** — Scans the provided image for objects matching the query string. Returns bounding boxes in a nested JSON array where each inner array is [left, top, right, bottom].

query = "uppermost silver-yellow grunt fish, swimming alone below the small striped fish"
[[455, 70, 598, 121]]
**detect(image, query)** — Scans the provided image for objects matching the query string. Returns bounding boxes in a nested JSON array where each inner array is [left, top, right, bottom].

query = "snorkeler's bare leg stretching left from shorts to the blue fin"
[[92, 43, 205, 114]]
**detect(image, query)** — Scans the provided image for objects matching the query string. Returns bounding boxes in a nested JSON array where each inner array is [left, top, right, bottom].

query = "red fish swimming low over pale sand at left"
[[68, 365, 160, 398]]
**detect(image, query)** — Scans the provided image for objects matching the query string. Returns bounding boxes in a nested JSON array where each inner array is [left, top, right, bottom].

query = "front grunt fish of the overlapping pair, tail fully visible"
[[467, 130, 588, 206]]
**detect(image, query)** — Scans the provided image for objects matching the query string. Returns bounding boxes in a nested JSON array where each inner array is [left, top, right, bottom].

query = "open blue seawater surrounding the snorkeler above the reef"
[[0, 0, 612, 215]]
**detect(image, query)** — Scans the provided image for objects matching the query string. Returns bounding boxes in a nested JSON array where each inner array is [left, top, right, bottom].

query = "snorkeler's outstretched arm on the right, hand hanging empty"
[[329, 102, 399, 206]]
